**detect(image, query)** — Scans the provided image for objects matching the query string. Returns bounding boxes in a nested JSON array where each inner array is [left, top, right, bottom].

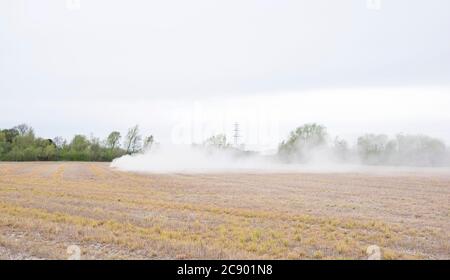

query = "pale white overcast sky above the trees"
[[0, 0, 450, 151]]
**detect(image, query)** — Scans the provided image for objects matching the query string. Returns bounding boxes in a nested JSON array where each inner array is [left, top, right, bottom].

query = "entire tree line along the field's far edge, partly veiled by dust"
[[0, 123, 450, 166]]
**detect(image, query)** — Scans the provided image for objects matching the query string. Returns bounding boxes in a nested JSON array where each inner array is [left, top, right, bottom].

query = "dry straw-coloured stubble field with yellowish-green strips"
[[0, 162, 450, 259]]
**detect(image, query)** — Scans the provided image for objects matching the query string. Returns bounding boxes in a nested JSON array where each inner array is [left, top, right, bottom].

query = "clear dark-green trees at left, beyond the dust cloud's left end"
[[0, 124, 154, 161]]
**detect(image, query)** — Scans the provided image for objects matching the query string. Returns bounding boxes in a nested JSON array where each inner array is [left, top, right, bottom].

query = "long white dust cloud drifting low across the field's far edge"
[[111, 141, 450, 173]]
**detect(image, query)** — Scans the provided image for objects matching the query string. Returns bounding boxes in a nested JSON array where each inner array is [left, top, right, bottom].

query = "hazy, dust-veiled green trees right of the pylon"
[[278, 123, 450, 166]]
